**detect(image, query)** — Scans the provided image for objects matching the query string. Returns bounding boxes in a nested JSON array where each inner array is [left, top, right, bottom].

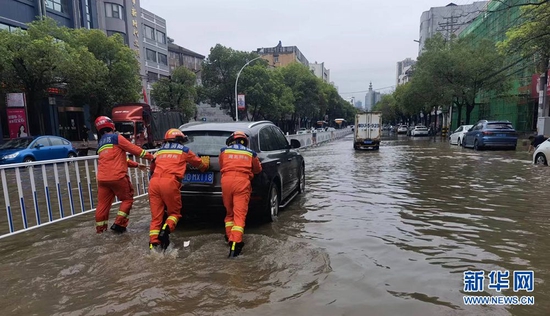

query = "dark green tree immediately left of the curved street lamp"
[[200, 44, 267, 117]]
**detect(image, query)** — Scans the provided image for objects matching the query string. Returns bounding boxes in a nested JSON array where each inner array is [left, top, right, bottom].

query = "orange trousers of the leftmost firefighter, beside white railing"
[[95, 175, 134, 233]]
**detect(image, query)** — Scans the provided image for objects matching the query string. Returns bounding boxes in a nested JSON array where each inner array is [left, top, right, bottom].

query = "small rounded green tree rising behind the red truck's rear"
[[151, 66, 197, 120]]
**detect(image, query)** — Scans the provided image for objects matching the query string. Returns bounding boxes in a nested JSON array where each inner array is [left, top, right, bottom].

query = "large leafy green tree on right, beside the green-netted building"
[[395, 34, 508, 123]]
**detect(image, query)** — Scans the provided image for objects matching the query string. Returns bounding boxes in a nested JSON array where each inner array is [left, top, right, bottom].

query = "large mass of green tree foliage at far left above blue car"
[[0, 18, 141, 134]]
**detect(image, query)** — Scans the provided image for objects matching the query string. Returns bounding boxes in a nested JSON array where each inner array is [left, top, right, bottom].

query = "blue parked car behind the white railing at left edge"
[[0, 136, 77, 164]]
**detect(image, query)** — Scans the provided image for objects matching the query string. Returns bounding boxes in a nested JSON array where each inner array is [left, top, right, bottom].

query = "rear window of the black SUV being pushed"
[[183, 131, 231, 157]]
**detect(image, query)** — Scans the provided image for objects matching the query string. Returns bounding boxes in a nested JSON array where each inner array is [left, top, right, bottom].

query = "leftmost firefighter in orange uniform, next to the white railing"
[[95, 116, 153, 233]]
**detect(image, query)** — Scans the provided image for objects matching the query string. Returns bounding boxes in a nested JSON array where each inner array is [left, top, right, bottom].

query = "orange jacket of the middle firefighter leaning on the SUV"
[[151, 143, 208, 182]]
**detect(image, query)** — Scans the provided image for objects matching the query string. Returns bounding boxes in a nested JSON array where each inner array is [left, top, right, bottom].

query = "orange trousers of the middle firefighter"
[[149, 175, 181, 244]]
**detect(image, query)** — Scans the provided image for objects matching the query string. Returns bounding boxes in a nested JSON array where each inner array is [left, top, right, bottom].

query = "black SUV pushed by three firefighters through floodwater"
[[179, 121, 306, 221]]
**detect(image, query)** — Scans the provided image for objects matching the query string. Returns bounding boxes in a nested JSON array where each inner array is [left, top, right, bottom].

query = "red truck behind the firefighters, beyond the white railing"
[[111, 103, 185, 149]]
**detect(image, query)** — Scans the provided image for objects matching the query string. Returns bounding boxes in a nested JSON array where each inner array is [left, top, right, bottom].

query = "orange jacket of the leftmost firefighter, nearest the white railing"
[[97, 133, 152, 181]]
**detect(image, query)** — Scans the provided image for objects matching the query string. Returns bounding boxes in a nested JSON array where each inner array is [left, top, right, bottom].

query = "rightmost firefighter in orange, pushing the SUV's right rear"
[[219, 131, 262, 257]]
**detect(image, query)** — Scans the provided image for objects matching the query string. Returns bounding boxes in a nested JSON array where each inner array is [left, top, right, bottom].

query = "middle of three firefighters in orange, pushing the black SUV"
[[149, 128, 209, 250]]
